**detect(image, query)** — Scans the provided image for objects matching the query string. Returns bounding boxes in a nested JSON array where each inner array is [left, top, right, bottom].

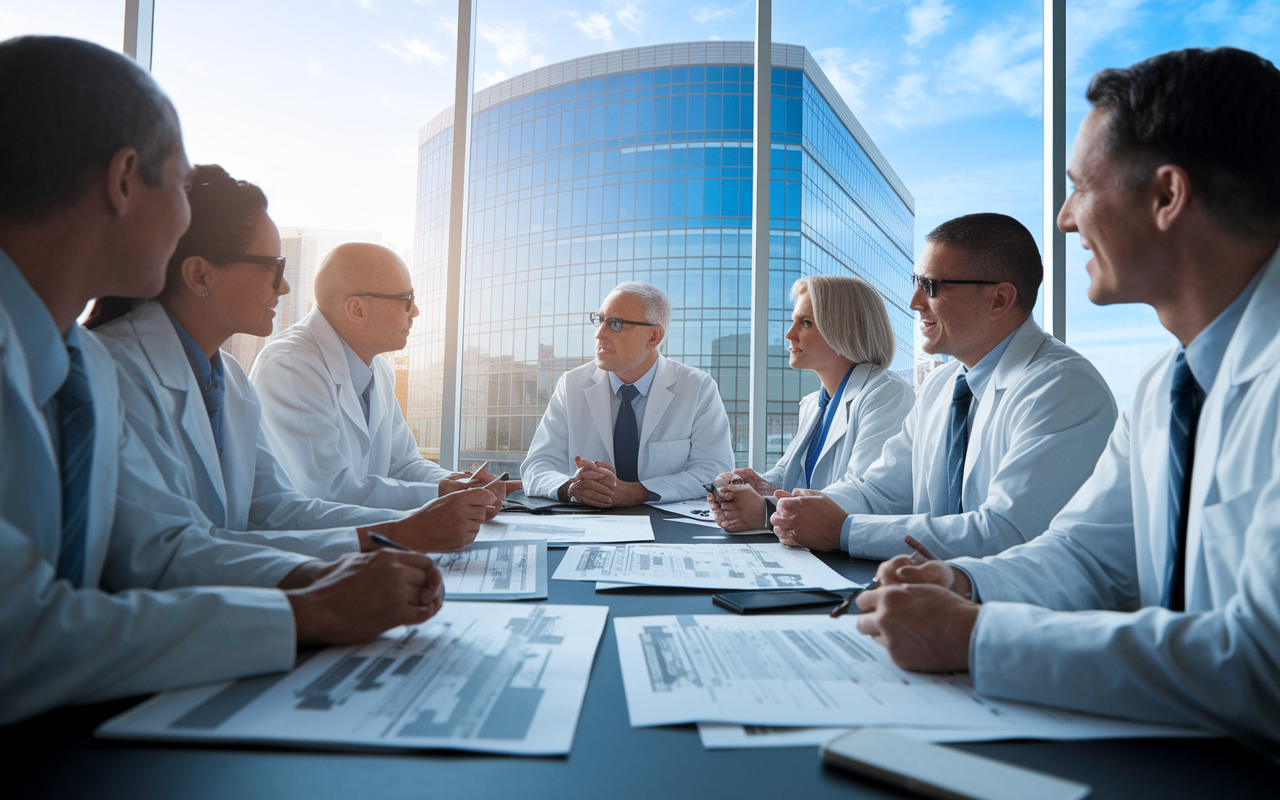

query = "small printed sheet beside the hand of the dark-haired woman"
[[428, 539, 547, 600]]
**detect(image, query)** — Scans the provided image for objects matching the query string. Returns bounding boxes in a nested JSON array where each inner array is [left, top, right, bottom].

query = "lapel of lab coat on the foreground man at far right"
[[1177, 251, 1280, 611]]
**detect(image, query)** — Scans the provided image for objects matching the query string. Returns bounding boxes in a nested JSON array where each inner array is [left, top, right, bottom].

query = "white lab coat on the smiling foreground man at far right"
[[956, 248, 1280, 742]]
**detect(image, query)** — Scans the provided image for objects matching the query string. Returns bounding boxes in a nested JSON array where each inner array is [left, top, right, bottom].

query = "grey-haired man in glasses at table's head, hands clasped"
[[521, 280, 733, 508]]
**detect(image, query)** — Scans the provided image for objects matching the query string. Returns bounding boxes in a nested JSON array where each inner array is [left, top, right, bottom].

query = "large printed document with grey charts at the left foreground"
[[97, 603, 608, 755]]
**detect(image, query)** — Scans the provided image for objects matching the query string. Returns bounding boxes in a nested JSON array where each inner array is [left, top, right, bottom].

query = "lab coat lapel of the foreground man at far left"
[[133, 302, 228, 525]]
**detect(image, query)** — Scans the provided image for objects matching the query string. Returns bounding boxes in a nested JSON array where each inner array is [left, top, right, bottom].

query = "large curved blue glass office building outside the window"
[[408, 42, 914, 475]]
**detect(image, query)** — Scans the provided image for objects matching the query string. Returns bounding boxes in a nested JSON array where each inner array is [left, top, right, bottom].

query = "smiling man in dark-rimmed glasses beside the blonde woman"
[[773, 214, 1116, 558]]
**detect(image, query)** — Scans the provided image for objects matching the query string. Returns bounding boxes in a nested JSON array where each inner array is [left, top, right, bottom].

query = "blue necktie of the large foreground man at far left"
[[54, 347, 93, 589]]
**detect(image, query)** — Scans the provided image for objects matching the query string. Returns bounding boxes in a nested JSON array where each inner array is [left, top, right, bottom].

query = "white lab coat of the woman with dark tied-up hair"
[[95, 302, 401, 559]]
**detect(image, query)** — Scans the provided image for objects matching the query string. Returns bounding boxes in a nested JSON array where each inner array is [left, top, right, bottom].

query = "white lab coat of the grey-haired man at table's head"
[[520, 355, 733, 502]]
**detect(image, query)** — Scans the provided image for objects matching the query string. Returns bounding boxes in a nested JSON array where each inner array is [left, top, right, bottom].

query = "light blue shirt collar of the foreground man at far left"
[[0, 244, 70, 408]]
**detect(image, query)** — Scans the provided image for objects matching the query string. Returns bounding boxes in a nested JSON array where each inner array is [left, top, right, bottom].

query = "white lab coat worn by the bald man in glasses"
[[250, 308, 449, 511]]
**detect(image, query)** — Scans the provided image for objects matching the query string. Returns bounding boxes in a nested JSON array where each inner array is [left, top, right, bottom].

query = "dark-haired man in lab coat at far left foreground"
[[0, 37, 443, 723]]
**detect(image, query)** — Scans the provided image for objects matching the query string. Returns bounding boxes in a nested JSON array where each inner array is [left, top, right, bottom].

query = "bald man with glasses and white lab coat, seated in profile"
[[250, 242, 509, 509]]
